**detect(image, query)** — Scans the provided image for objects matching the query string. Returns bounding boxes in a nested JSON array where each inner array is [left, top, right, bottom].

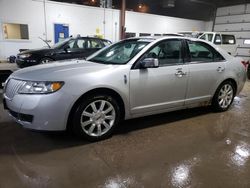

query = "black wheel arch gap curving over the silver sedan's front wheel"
[[66, 88, 125, 129]]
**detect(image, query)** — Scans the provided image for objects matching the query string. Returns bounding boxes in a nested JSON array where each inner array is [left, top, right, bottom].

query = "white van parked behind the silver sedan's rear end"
[[198, 32, 237, 56]]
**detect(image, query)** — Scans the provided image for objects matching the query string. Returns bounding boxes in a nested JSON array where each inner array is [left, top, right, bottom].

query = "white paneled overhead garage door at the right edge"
[[214, 4, 250, 60]]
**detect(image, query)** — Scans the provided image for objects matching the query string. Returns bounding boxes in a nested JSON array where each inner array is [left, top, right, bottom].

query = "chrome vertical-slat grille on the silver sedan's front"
[[5, 79, 25, 99]]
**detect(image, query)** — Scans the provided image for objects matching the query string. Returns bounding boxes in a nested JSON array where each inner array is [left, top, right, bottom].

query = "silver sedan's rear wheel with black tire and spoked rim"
[[212, 81, 236, 112]]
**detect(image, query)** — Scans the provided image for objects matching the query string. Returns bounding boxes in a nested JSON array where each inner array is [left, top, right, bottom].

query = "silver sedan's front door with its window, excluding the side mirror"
[[130, 39, 188, 115]]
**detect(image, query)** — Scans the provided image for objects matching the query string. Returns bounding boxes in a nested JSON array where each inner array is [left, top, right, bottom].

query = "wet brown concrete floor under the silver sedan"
[[0, 82, 250, 188]]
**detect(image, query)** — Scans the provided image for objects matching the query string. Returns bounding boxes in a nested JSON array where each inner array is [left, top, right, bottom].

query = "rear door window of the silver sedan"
[[187, 41, 224, 63]]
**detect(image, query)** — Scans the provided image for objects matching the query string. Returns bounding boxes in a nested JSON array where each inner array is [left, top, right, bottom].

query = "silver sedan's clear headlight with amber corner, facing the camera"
[[18, 81, 64, 94]]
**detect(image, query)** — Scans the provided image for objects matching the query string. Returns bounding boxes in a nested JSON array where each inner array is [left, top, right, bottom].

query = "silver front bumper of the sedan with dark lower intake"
[[3, 91, 73, 131]]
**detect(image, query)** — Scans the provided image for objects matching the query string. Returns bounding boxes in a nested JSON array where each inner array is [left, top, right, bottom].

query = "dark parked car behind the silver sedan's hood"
[[16, 37, 111, 68]]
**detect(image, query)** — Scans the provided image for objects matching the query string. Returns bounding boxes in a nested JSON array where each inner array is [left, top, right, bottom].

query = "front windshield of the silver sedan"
[[88, 39, 151, 64]]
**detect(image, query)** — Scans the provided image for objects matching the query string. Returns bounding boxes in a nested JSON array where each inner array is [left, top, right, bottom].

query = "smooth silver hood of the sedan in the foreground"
[[11, 60, 118, 81]]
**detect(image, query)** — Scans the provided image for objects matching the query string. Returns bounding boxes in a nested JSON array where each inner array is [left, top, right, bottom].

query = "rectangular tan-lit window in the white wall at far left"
[[3, 23, 29, 40]]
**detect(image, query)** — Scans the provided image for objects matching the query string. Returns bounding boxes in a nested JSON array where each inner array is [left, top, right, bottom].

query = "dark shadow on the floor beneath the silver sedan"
[[0, 107, 214, 155]]
